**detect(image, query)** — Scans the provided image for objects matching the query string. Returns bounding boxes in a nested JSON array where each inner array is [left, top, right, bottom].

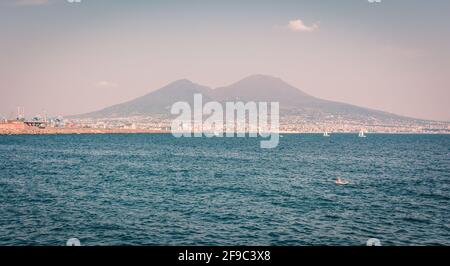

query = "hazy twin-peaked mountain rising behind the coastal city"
[[74, 75, 410, 120]]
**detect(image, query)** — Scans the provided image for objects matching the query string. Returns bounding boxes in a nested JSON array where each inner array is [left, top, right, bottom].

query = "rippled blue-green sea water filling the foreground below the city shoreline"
[[0, 134, 450, 246]]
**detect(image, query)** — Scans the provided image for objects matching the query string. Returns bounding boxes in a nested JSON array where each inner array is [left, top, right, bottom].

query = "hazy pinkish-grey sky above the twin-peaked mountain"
[[0, 0, 450, 121]]
